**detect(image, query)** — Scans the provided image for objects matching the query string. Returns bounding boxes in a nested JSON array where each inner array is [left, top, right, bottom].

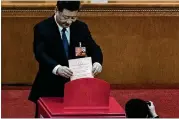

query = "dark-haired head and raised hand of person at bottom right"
[[125, 99, 158, 118]]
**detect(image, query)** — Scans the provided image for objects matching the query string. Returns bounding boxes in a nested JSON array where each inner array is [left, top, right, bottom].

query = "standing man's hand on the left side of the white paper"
[[57, 66, 73, 78]]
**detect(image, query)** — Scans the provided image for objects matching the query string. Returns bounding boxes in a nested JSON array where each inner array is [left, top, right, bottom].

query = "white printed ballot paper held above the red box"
[[68, 57, 94, 80]]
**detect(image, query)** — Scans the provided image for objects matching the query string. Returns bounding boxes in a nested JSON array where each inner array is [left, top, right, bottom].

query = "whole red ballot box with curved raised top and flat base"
[[38, 78, 125, 118]]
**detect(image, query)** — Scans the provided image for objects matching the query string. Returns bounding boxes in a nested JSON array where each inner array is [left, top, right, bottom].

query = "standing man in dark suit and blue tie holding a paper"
[[29, 1, 103, 117]]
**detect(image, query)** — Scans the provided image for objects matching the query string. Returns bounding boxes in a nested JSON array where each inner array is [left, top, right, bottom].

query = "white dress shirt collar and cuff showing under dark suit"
[[52, 15, 70, 75]]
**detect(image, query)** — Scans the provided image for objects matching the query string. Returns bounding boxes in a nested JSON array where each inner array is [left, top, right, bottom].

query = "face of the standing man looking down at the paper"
[[56, 9, 78, 28]]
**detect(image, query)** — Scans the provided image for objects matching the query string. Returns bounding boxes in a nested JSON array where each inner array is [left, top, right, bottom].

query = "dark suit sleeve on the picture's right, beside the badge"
[[84, 24, 103, 65]]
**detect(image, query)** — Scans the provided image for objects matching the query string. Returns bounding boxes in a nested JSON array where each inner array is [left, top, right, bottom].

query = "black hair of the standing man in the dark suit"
[[57, 0, 80, 11]]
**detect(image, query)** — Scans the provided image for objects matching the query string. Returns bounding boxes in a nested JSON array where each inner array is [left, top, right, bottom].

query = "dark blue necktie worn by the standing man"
[[62, 28, 69, 58]]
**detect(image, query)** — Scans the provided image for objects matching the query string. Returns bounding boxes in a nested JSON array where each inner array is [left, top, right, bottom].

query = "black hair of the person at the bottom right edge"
[[125, 99, 149, 118]]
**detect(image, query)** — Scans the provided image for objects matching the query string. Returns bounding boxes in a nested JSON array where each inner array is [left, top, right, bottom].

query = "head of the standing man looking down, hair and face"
[[55, 1, 80, 28]]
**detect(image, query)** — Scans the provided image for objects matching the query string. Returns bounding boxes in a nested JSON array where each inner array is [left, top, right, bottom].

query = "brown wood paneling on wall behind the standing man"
[[2, 5, 179, 87]]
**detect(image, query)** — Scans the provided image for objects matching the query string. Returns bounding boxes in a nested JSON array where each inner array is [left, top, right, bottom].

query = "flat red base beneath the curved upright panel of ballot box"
[[38, 97, 125, 118]]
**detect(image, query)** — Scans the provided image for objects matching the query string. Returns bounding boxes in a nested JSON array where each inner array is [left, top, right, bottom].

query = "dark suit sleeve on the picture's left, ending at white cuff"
[[33, 26, 58, 71]]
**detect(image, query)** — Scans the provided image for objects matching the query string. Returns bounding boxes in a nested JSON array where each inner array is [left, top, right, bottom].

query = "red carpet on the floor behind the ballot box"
[[1, 89, 179, 118]]
